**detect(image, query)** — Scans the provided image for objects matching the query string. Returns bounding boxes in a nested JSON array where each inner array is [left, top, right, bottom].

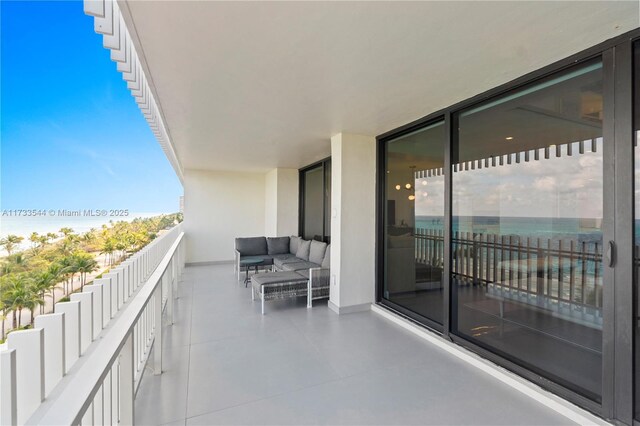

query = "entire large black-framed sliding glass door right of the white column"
[[377, 29, 640, 424]]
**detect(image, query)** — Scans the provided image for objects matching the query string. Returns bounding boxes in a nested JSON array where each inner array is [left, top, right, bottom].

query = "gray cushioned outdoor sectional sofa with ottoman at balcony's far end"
[[235, 237, 331, 314]]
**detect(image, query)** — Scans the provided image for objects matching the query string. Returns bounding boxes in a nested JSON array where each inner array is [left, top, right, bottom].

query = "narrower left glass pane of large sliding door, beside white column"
[[384, 121, 446, 324]]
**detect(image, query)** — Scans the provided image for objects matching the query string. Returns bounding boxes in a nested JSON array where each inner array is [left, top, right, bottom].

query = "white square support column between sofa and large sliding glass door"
[[329, 133, 376, 314]]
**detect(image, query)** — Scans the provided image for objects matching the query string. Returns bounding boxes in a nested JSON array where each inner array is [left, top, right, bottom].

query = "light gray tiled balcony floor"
[[135, 265, 594, 425]]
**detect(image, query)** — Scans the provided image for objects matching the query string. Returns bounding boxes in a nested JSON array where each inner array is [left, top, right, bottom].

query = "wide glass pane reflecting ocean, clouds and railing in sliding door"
[[451, 61, 604, 402]]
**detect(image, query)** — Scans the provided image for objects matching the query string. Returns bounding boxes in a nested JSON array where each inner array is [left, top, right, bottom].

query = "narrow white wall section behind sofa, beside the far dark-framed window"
[[265, 168, 299, 237]]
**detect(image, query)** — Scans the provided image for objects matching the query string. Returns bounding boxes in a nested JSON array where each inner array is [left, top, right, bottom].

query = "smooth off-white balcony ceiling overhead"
[[120, 1, 640, 171]]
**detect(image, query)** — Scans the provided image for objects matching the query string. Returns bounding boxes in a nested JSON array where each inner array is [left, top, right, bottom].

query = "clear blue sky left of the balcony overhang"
[[0, 1, 183, 212]]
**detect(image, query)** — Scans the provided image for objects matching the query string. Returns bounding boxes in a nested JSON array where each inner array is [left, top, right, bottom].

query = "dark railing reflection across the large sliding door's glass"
[[415, 228, 602, 326]]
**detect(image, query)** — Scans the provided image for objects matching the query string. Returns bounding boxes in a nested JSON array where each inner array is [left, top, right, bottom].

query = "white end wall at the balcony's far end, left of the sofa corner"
[[184, 170, 266, 263]]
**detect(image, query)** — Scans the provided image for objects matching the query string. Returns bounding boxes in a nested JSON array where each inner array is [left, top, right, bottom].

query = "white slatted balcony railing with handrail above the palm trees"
[[0, 225, 184, 425]]
